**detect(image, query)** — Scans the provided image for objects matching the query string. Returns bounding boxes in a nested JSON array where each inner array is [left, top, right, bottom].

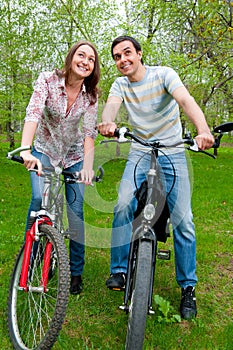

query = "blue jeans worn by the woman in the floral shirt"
[[26, 148, 85, 276]]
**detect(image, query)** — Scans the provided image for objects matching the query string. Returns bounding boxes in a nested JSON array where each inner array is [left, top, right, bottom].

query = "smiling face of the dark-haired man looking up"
[[113, 40, 144, 81]]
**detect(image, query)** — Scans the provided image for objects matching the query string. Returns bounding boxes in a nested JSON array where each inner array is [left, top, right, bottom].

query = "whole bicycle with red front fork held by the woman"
[[7, 147, 103, 350]]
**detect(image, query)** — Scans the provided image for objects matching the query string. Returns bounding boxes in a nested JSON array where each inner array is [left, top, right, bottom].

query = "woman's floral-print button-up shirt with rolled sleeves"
[[25, 72, 98, 168]]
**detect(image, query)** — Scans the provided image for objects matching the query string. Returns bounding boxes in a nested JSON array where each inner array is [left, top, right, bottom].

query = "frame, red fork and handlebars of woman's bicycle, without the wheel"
[[7, 146, 104, 293]]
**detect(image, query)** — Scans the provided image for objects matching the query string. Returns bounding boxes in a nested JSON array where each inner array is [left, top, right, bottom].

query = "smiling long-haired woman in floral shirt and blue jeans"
[[21, 41, 100, 294]]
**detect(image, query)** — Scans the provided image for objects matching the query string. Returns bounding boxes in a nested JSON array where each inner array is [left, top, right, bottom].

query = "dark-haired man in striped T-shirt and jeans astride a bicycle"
[[99, 36, 214, 319]]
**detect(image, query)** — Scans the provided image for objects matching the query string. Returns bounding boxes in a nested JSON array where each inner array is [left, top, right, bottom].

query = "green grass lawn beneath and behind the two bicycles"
[[0, 137, 233, 350]]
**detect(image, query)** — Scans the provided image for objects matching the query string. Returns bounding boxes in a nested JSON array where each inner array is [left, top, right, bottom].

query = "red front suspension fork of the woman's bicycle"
[[19, 217, 52, 293]]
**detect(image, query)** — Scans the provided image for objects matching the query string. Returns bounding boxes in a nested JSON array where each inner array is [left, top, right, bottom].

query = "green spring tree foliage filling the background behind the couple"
[[0, 0, 233, 142]]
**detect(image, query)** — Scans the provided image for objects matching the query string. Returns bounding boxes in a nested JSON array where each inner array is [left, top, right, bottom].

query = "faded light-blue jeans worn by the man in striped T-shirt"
[[111, 151, 197, 288]]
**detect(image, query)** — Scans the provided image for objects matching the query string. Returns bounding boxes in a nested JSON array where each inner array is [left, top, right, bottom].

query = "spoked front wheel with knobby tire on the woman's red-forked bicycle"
[[8, 225, 70, 350]]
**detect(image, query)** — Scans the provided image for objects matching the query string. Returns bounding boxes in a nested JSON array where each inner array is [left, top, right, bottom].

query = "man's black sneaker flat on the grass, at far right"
[[180, 286, 197, 320]]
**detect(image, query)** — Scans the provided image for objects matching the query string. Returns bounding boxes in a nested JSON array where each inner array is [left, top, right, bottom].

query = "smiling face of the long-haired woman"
[[71, 45, 95, 79]]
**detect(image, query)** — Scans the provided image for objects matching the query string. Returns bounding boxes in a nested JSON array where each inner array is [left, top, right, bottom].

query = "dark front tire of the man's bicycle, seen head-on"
[[125, 240, 152, 350]]
